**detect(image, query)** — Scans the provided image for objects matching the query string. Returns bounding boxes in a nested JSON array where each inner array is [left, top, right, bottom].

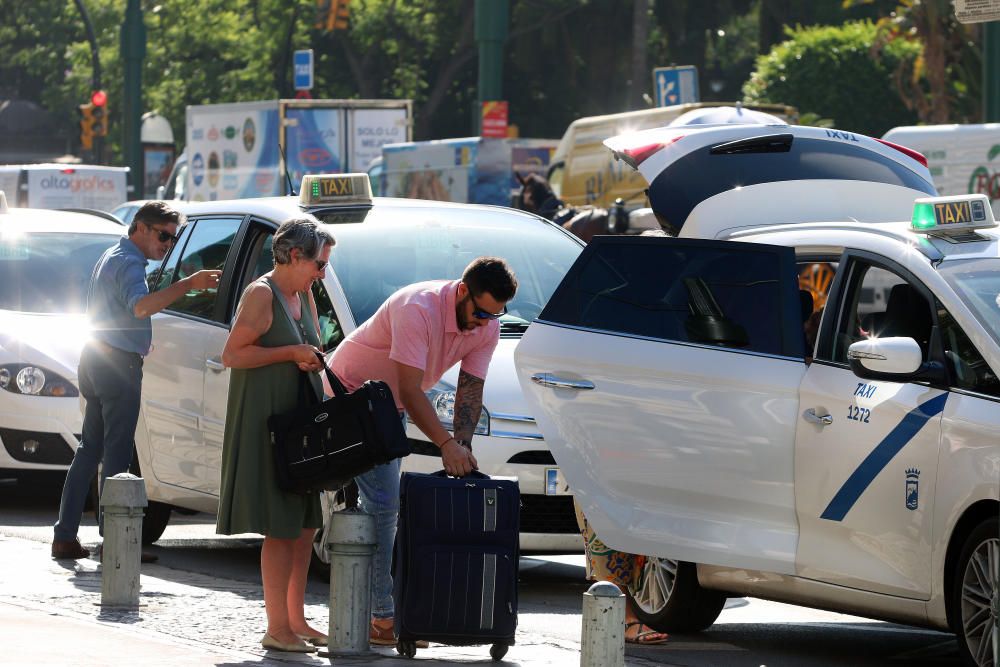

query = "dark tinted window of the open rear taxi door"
[[540, 237, 804, 357]]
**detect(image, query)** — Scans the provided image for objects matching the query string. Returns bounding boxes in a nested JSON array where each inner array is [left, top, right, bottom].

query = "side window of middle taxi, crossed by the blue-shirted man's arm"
[[160, 218, 243, 319]]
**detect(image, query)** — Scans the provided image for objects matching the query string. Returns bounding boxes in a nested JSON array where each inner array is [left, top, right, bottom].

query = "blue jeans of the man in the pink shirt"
[[354, 456, 405, 618]]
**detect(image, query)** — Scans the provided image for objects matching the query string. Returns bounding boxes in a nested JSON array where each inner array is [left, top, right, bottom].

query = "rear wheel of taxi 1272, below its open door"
[[625, 556, 726, 633]]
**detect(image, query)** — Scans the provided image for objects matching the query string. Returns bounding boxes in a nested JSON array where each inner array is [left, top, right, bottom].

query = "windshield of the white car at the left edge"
[[0, 232, 121, 313]]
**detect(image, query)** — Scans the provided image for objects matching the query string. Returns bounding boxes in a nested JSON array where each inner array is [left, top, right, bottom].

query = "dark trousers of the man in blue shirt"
[[55, 342, 142, 540]]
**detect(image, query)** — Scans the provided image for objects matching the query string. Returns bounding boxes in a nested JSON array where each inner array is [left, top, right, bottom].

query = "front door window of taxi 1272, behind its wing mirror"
[[817, 260, 934, 364]]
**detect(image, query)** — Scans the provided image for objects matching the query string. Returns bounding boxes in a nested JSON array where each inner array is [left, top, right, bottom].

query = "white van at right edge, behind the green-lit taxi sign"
[[882, 123, 1000, 217]]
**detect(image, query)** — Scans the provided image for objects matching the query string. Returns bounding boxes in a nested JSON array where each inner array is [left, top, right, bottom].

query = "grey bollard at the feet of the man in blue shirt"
[[101, 472, 148, 607]]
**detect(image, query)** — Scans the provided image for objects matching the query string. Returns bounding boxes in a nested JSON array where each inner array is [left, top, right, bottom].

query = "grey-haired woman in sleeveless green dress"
[[217, 218, 334, 653]]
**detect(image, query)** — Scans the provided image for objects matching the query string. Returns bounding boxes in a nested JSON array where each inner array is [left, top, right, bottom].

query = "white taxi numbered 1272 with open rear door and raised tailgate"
[[516, 138, 1000, 665]]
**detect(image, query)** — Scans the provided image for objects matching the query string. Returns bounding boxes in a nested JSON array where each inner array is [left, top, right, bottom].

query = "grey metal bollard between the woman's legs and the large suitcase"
[[326, 510, 375, 655]]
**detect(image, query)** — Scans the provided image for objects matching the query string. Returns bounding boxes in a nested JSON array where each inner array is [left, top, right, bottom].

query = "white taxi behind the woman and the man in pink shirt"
[[136, 174, 582, 552]]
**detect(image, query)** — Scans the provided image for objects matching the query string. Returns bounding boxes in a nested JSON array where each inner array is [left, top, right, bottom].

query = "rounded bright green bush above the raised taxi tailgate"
[[743, 21, 919, 137]]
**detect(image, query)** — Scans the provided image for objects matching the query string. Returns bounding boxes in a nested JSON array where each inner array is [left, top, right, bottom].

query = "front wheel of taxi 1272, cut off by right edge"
[[951, 517, 1000, 667]]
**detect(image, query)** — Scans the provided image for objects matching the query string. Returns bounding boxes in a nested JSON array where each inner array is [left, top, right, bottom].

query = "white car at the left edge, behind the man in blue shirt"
[[0, 198, 124, 478]]
